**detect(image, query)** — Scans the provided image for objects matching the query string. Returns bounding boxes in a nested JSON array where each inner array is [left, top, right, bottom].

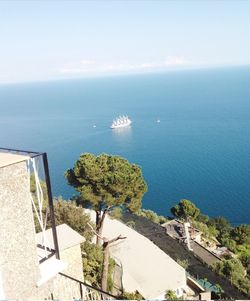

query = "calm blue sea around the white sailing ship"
[[0, 67, 250, 224]]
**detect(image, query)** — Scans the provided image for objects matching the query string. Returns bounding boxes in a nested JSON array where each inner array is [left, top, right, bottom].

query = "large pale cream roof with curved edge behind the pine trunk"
[[86, 210, 186, 299]]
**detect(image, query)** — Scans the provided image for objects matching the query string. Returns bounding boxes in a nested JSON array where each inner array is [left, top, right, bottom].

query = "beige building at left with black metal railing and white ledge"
[[0, 149, 113, 300]]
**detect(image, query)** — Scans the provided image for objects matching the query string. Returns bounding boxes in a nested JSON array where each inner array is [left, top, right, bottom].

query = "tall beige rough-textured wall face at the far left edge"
[[0, 162, 39, 299]]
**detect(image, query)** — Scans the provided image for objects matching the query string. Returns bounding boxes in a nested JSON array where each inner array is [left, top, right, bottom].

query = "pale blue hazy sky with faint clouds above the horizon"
[[0, 0, 250, 83]]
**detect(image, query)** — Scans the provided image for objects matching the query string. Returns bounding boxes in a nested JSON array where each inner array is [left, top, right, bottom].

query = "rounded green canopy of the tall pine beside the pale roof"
[[65, 153, 147, 211]]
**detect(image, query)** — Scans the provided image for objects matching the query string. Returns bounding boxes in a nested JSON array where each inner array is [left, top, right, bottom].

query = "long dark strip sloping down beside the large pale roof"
[[122, 213, 250, 300]]
